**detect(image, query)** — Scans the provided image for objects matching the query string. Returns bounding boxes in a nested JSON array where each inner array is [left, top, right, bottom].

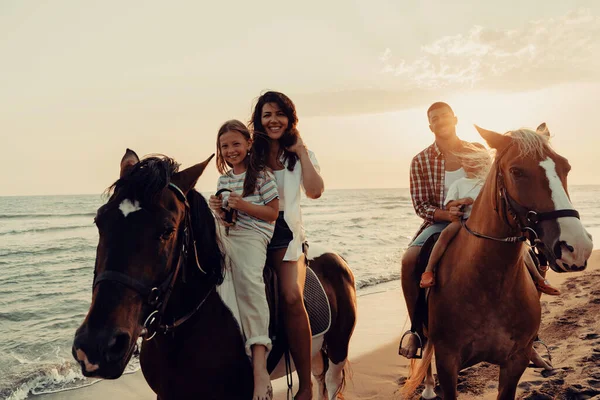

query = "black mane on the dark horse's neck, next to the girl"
[[187, 189, 224, 285]]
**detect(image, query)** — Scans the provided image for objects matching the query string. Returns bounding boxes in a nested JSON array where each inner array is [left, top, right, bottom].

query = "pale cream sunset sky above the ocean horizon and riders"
[[0, 0, 600, 196]]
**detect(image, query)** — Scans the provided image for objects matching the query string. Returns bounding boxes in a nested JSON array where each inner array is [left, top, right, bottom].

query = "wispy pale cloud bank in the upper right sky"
[[379, 10, 600, 90]]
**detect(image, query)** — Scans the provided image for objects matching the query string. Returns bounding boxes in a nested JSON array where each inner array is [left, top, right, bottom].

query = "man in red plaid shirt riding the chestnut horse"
[[399, 102, 480, 358]]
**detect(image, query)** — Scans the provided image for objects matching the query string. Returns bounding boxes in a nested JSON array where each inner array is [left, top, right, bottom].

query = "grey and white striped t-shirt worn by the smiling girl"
[[217, 171, 279, 240]]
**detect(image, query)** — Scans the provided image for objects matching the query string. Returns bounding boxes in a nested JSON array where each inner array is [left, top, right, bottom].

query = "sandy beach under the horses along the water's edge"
[[33, 250, 600, 400]]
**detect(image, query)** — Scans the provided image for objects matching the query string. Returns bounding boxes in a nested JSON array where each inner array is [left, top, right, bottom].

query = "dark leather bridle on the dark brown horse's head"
[[92, 183, 214, 340]]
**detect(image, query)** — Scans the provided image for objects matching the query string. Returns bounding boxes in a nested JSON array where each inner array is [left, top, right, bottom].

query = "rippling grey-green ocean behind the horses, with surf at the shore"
[[0, 186, 600, 400]]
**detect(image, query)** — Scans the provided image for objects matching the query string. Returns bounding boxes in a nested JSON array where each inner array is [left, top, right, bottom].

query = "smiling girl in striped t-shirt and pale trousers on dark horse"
[[209, 120, 279, 400]]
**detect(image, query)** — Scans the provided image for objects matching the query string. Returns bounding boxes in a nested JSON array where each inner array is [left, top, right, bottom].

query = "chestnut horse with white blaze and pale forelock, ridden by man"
[[402, 124, 592, 400]]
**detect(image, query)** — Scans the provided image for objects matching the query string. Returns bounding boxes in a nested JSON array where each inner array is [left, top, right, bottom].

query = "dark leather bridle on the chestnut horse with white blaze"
[[461, 142, 579, 266]]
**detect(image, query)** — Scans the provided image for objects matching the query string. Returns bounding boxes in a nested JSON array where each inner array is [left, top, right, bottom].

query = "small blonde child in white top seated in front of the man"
[[419, 146, 560, 296]]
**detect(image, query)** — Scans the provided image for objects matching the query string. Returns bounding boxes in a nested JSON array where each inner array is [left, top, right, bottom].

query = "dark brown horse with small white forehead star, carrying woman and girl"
[[73, 150, 356, 400]]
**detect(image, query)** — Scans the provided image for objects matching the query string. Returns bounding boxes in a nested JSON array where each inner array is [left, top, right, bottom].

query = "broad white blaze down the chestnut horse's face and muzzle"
[[540, 157, 593, 267]]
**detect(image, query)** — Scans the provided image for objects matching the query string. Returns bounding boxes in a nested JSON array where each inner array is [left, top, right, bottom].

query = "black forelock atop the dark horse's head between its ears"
[[106, 155, 179, 206]]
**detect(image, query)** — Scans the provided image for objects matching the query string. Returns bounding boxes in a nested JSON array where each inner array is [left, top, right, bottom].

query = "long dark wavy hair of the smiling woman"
[[248, 91, 298, 171]]
